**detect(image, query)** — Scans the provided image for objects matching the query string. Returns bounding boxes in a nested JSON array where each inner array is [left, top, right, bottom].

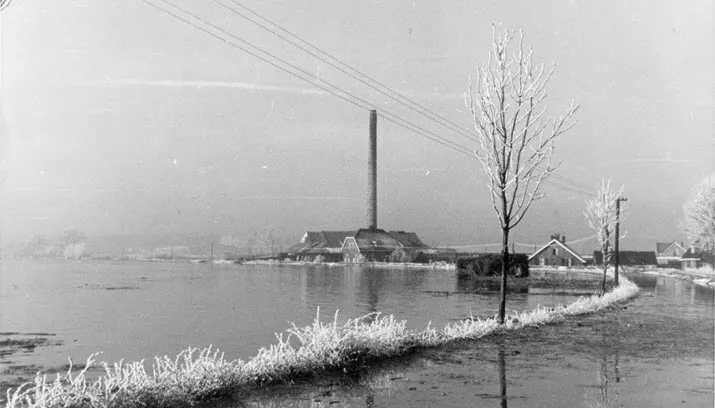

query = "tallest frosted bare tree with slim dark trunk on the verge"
[[465, 28, 578, 323]]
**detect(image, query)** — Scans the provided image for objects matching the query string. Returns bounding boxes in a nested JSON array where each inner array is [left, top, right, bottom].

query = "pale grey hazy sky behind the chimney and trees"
[[0, 0, 715, 250]]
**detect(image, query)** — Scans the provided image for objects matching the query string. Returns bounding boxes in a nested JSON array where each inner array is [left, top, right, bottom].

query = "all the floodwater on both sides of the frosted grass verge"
[[0, 262, 715, 408]]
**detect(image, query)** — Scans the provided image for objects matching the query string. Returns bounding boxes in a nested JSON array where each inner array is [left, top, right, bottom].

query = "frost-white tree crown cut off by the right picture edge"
[[683, 174, 715, 254]]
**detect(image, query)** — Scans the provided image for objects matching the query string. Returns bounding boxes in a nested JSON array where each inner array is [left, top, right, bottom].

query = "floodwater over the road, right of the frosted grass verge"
[[232, 274, 715, 408]]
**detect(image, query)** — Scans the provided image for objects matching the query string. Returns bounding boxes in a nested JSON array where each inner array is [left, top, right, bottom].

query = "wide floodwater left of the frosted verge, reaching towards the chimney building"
[[0, 261, 590, 386]]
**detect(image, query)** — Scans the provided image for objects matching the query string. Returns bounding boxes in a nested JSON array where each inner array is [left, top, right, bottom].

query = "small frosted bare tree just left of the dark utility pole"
[[583, 180, 628, 292]]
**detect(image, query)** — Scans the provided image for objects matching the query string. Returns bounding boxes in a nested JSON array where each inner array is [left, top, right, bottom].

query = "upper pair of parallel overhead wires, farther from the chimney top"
[[213, 0, 476, 140]]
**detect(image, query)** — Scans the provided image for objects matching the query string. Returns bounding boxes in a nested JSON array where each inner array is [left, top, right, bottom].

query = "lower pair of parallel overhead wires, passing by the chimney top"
[[143, 0, 471, 156]]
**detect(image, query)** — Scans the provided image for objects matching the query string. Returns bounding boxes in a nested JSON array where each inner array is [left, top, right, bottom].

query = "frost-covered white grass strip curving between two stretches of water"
[[6, 277, 638, 408]]
